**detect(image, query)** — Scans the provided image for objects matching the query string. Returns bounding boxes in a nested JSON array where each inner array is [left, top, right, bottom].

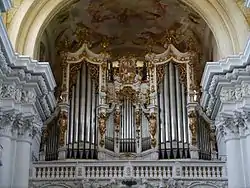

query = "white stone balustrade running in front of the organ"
[[30, 160, 227, 181]]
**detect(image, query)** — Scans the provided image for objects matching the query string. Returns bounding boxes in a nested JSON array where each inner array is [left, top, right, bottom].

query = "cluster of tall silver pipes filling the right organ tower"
[[158, 62, 189, 159]]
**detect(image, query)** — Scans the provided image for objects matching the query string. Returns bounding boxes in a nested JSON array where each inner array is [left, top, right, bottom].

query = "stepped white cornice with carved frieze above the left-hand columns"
[[0, 13, 56, 121]]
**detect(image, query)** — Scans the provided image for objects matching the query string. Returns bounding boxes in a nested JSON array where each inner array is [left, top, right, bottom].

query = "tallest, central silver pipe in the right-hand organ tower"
[[169, 63, 177, 140]]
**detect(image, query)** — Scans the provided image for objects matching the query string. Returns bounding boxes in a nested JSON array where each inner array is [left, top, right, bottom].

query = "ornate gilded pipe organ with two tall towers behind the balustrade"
[[41, 44, 217, 159]]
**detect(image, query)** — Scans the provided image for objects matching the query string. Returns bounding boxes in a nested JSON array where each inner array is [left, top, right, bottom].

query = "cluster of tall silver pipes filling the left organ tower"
[[67, 63, 98, 159]]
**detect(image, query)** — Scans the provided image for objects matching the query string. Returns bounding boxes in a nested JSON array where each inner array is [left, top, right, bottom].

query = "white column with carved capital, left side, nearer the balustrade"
[[13, 118, 41, 188]]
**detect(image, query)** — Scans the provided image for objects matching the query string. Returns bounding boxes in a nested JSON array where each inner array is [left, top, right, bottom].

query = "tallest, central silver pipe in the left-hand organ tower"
[[80, 64, 86, 141]]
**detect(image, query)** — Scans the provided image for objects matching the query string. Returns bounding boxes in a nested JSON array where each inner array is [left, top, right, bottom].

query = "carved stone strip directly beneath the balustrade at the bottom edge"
[[29, 178, 227, 188]]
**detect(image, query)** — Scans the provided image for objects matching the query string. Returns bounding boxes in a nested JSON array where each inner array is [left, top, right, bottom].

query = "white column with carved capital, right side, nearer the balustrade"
[[217, 115, 246, 188]]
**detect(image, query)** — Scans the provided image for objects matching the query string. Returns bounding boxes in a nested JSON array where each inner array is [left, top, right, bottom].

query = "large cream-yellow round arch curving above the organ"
[[8, 0, 248, 58]]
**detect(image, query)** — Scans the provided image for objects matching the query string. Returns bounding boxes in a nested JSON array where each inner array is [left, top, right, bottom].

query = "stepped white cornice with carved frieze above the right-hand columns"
[[201, 37, 250, 119]]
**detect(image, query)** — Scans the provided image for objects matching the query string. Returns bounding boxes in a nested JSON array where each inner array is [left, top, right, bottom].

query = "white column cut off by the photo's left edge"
[[0, 111, 13, 187]]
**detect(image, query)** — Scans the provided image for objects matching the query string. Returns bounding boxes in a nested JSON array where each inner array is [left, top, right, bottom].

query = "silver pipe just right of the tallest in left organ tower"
[[85, 74, 92, 142]]
